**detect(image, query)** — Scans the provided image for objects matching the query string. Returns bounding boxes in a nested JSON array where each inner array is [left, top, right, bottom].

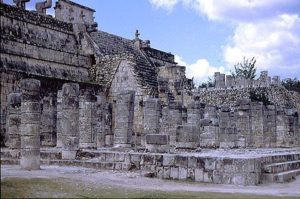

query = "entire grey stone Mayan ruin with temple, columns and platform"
[[0, 0, 300, 185]]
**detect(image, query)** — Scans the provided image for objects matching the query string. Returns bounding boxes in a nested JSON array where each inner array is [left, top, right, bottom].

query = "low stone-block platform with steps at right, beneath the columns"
[[1, 148, 300, 185]]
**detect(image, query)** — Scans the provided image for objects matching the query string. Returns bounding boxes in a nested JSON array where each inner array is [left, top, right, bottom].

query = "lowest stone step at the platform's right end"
[[262, 169, 300, 183]]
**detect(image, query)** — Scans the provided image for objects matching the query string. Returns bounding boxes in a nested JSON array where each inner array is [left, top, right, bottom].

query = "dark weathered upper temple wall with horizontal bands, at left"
[[0, 4, 90, 81]]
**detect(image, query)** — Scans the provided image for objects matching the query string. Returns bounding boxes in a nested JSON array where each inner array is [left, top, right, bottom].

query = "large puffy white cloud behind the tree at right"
[[224, 14, 300, 75]]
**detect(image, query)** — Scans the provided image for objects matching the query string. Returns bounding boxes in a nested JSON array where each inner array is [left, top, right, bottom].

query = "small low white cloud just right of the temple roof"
[[175, 55, 225, 85]]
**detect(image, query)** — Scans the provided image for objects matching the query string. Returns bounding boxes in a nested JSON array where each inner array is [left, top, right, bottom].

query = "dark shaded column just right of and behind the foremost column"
[[41, 93, 57, 147]]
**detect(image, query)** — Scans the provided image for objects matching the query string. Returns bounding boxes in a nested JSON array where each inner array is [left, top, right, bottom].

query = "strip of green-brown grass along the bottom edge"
[[1, 178, 296, 199]]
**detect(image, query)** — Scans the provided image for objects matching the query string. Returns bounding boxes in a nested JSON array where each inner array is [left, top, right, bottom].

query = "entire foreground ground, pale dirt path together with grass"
[[1, 165, 300, 198]]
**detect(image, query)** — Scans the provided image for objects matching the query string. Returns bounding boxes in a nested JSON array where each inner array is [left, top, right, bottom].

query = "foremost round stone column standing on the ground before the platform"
[[20, 79, 41, 170]]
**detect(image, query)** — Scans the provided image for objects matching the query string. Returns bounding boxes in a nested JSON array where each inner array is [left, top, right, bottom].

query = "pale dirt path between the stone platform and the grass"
[[1, 165, 300, 198]]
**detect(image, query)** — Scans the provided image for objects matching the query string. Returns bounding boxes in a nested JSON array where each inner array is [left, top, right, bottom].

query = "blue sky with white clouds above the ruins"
[[4, 0, 300, 84]]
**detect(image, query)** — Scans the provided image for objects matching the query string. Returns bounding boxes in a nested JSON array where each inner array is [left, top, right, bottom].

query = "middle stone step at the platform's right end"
[[263, 160, 300, 173]]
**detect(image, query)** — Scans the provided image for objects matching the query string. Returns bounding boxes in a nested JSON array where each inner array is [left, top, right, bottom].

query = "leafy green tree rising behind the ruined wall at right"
[[231, 57, 256, 79]]
